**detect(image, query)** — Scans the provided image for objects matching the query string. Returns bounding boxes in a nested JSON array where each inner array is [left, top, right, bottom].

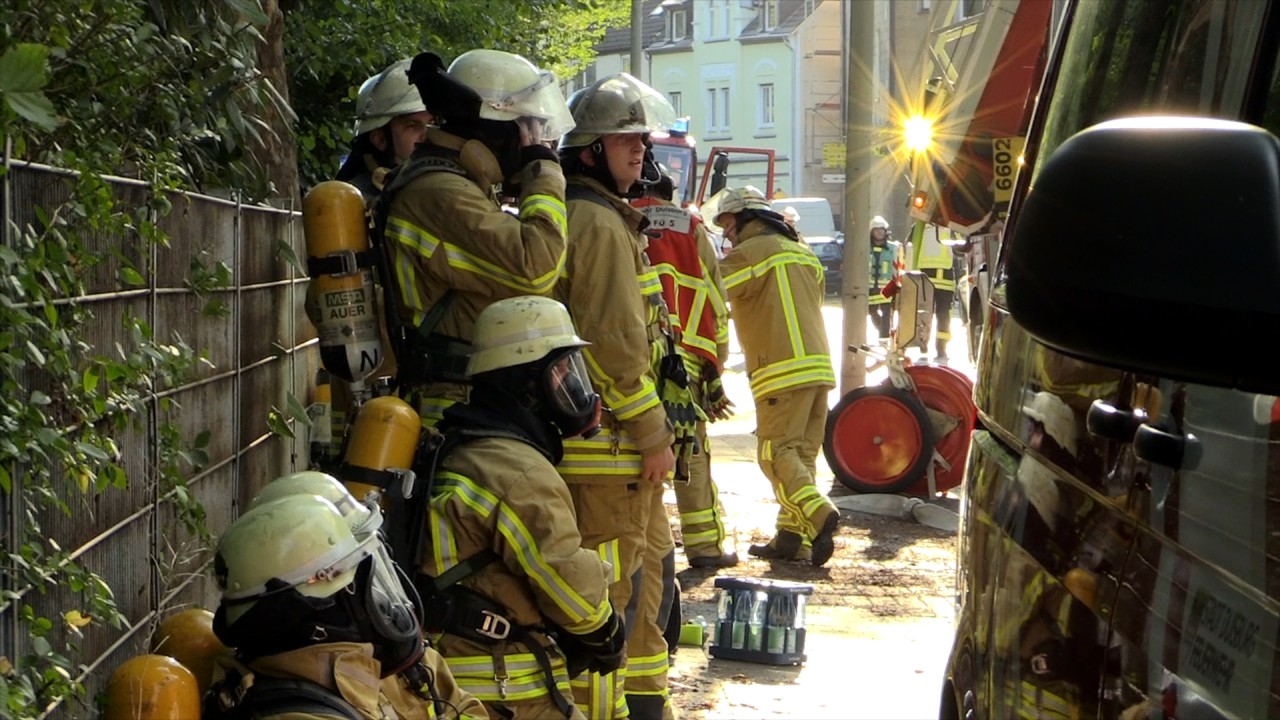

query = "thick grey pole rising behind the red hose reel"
[[840, 0, 876, 395]]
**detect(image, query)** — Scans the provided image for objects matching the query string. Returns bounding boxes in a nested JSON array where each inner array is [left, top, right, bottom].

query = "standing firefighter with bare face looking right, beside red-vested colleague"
[[557, 73, 676, 717]]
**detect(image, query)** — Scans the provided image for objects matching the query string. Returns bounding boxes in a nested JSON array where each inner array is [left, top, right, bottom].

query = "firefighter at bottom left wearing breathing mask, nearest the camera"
[[202, 493, 489, 719]]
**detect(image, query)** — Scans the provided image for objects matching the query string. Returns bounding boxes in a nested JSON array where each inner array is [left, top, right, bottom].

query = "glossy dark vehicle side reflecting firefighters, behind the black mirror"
[[941, 0, 1280, 719]]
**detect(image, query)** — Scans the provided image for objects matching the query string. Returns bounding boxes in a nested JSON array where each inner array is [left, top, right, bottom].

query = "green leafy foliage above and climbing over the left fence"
[[0, 0, 619, 717]]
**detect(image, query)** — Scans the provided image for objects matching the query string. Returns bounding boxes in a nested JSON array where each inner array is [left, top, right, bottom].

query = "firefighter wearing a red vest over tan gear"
[[634, 165, 737, 568]]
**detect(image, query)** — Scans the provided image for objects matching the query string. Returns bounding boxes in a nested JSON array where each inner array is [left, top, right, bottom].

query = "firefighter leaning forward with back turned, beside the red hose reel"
[[707, 186, 840, 566]]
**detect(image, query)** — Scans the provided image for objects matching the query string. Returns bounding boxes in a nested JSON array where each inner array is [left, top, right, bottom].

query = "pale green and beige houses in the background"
[[578, 0, 942, 228]]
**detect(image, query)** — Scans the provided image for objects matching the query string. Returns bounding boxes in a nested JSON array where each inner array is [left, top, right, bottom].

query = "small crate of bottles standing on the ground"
[[709, 578, 813, 665]]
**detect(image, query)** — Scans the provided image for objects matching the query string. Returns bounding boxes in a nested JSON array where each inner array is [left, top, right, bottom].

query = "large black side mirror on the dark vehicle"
[[993, 117, 1280, 395]]
